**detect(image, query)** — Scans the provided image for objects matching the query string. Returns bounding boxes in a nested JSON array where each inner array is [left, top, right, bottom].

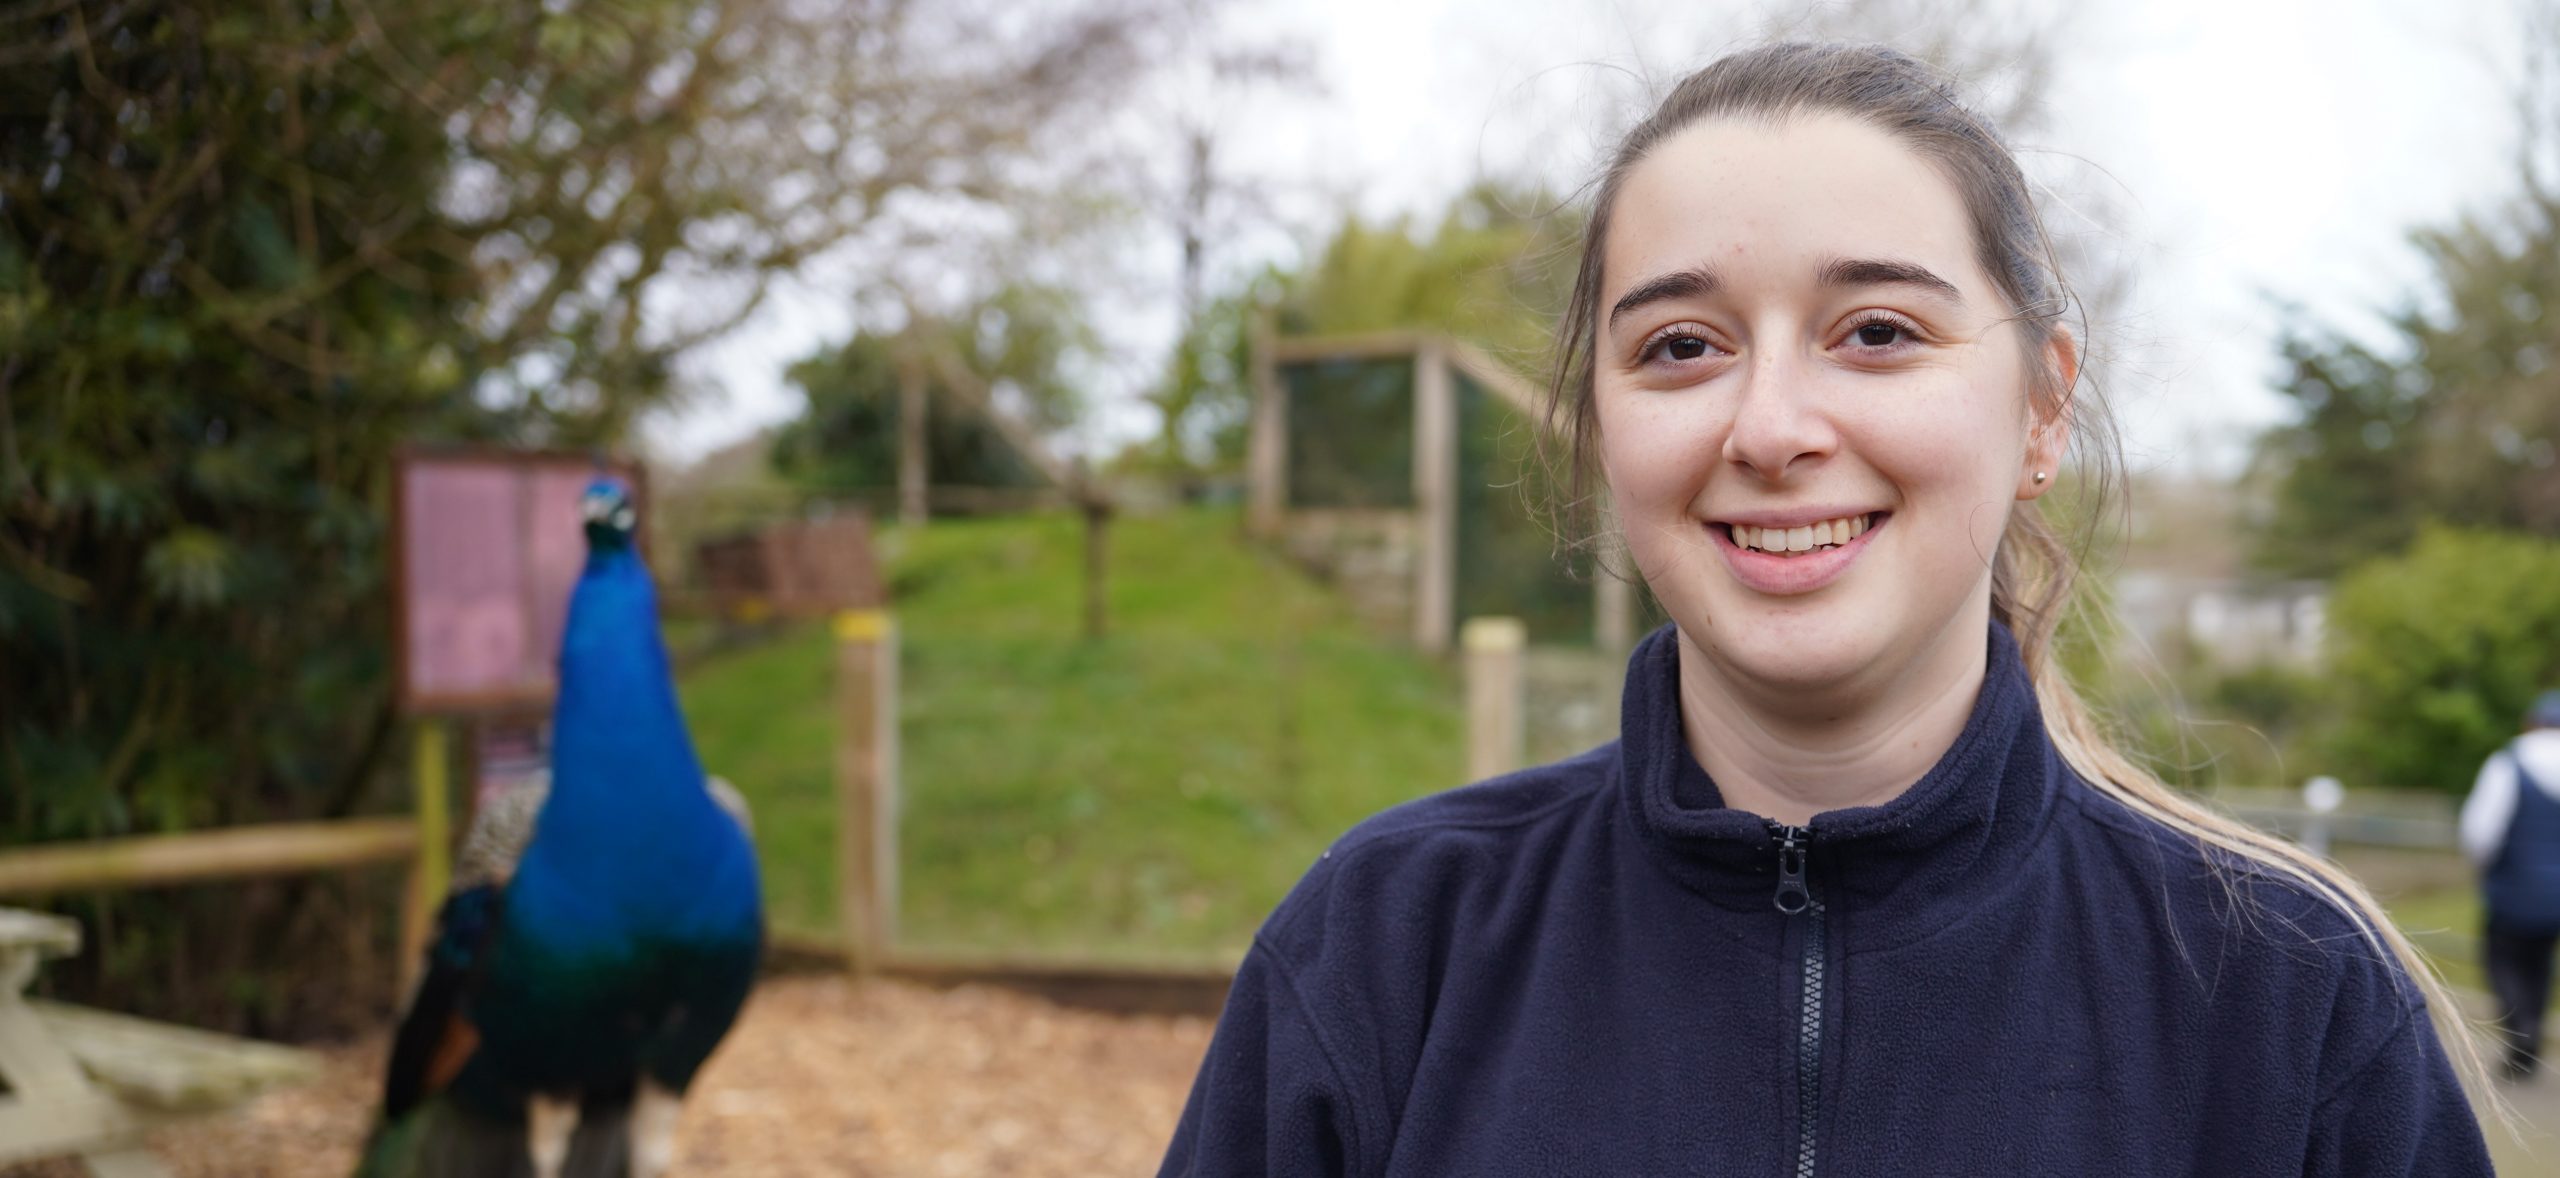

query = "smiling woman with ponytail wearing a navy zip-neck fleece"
[[1165, 44, 2488, 1178]]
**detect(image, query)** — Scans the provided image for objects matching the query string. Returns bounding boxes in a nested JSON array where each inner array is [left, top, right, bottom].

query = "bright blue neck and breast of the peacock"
[[522, 545, 745, 922]]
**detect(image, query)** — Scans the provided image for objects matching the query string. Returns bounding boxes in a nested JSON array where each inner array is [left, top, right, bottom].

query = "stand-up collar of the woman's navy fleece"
[[1618, 622, 2066, 945]]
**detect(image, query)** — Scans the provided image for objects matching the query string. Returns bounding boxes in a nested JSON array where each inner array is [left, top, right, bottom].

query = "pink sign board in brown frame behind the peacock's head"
[[392, 451, 640, 714]]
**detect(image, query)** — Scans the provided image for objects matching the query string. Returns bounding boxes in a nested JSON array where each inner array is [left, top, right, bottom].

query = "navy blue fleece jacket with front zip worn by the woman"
[[1162, 625, 2488, 1178]]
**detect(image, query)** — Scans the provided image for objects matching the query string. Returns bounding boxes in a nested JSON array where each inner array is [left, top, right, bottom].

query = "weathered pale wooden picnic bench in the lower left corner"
[[0, 907, 317, 1178]]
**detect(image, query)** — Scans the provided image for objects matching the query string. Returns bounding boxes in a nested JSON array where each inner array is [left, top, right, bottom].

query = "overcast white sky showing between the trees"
[[648, 0, 2519, 478]]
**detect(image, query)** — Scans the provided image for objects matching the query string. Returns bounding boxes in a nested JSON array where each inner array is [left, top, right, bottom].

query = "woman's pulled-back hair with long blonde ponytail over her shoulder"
[[1544, 44, 2511, 1106]]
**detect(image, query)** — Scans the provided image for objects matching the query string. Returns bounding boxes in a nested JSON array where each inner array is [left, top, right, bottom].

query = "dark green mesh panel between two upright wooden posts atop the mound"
[[1280, 356, 1413, 507]]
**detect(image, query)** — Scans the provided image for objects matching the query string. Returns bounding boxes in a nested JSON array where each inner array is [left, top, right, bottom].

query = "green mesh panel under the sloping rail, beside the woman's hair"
[[1452, 371, 1592, 645]]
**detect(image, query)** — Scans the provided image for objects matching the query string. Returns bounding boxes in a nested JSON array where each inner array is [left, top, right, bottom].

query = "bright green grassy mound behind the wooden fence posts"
[[681, 510, 1464, 958]]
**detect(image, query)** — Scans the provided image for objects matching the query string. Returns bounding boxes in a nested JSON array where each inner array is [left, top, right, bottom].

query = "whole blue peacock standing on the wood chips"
[[356, 479, 765, 1178]]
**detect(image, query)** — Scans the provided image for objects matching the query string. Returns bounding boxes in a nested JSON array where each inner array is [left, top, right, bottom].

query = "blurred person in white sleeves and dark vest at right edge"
[[2463, 691, 2560, 1081]]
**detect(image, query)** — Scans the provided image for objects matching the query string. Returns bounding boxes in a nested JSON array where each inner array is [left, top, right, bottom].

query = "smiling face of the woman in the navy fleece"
[[1592, 115, 2074, 694]]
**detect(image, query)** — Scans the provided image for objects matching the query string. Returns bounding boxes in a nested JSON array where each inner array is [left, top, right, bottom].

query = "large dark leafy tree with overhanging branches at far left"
[[0, 0, 1155, 1024]]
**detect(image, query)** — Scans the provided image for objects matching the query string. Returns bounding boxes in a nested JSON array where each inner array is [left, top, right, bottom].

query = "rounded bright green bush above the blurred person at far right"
[[2327, 525, 2560, 791]]
